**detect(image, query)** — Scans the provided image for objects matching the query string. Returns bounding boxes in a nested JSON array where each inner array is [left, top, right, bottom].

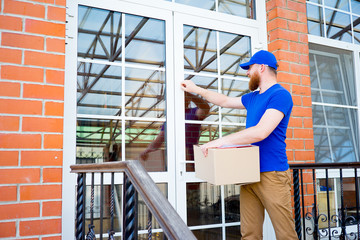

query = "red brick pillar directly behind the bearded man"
[[266, 0, 315, 214]]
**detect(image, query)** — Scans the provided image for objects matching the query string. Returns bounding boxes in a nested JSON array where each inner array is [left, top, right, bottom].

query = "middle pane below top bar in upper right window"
[[325, 9, 352, 43]]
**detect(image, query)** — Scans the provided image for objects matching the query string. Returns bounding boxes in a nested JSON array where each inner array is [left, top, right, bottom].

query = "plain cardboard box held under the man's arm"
[[194, 145, 260, 185]]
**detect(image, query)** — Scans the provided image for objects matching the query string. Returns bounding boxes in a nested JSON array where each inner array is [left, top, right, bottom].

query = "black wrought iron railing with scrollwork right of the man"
[[290, 163, 360, 240]]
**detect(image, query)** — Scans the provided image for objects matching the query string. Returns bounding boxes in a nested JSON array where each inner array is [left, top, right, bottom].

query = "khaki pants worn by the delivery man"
[[240, 170, 298, 240]]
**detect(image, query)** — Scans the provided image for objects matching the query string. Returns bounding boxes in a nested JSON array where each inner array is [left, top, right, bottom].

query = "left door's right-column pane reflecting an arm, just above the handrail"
[[125, 120, 167, 172]]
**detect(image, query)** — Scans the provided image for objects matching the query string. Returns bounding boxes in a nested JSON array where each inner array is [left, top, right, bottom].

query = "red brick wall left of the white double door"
[[0, 0, 66, 240]]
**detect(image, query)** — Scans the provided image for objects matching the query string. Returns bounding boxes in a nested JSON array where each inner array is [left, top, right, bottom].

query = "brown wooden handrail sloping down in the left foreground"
[[70, 161, 196, 240]]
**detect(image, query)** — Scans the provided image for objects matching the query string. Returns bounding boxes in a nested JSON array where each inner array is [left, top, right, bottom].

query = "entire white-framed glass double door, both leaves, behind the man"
[[64, 0, 271, 239]]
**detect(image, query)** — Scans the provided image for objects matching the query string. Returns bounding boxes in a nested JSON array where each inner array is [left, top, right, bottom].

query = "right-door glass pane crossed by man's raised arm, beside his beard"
[[221, 79, 249, 123]]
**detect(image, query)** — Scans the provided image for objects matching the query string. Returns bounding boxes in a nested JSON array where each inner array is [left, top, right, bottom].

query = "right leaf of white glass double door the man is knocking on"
[[174, 14, 258, 239]]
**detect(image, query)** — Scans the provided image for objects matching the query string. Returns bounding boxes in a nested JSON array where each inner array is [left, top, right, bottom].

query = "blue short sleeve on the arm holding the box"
[[267, 90, 293, 116]]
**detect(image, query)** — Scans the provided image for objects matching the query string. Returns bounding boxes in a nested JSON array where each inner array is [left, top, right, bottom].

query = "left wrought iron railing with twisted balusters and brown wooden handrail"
[[71, 161, 196, 240]]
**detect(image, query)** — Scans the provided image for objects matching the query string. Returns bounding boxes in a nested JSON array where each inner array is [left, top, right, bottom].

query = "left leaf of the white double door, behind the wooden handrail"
[[76, 1, 175, 237]]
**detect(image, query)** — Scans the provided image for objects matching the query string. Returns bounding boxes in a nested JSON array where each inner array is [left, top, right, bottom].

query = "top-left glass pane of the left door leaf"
[[78, 6, 121, 62]]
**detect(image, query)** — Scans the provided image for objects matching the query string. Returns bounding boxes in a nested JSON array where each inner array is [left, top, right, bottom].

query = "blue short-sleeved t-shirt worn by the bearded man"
[[241, 84, 293, 172]]
